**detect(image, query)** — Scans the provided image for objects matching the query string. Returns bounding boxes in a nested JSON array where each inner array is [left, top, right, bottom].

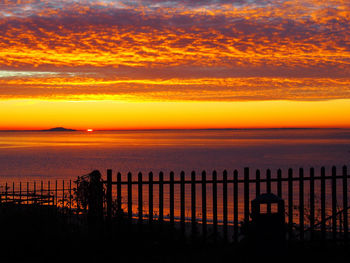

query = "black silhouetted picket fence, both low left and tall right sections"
[[0, 166, 350, 242]]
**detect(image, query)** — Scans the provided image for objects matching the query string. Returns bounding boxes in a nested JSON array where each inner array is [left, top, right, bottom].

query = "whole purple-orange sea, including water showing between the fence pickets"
[[0, 129, 350, 226]]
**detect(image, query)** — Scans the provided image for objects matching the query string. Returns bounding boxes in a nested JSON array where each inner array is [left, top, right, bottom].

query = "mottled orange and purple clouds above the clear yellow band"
[[0, 0, 350, 101]]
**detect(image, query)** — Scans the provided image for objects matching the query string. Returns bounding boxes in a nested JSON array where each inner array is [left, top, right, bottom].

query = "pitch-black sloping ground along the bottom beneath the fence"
[[0, 204, 350, 262]]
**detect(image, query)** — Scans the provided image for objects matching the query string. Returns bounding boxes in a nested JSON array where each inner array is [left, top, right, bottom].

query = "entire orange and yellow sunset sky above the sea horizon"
[[0, 0, 350, 129]]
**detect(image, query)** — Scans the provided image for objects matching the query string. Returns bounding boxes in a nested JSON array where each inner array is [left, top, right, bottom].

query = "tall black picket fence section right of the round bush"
[[104, 166, 350, 241]]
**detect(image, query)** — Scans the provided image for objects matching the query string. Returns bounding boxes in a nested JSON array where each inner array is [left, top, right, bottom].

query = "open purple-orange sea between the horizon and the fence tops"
[[0, 129, 350, 181]]
